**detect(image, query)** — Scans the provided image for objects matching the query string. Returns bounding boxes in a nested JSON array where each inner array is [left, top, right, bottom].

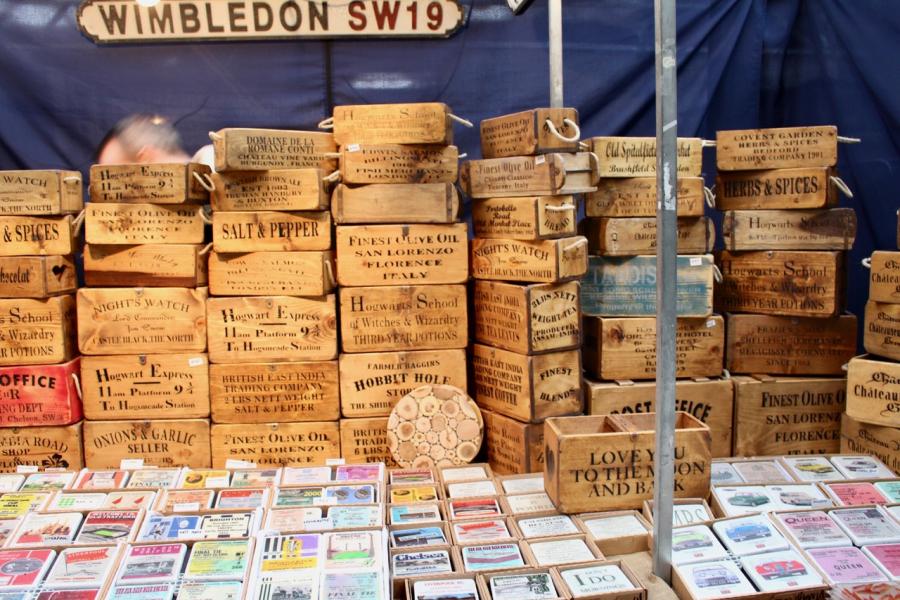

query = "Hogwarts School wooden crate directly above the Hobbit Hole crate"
[[340, 285, 469, 352]]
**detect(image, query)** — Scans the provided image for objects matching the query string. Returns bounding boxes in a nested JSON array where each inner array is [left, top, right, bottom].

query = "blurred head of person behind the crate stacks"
[[97, 114, 190, 165]]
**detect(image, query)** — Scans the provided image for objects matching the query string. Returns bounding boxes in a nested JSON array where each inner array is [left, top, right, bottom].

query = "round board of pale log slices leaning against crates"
[[388, 385, 484, 468]]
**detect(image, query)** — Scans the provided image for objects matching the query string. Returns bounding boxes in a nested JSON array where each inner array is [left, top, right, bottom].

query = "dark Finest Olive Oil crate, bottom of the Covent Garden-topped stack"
[[733, 376, 847, 456]]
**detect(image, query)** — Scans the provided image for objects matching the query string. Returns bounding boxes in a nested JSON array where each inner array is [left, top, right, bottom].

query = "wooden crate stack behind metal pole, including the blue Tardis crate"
[[582, 137, 733, 457]]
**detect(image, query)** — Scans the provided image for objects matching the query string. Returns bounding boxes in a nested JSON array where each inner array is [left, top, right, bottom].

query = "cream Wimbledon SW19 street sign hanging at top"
[[78, 0, 463, 44]]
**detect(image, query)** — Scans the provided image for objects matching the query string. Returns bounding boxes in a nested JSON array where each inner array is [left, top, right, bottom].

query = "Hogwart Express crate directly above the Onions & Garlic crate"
[[81, 353, 209, 421]]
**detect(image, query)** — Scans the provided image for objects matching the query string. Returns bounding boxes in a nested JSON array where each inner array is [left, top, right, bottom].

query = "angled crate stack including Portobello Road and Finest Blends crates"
[[460, 108, 598, 473]]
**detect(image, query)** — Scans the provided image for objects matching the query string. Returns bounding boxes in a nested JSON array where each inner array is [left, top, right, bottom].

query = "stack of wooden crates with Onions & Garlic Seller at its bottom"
[[77, 163, 210, 469]]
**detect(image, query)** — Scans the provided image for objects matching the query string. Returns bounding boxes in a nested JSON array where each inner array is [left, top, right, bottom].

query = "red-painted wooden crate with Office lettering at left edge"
[[0, 358, 82, 426]]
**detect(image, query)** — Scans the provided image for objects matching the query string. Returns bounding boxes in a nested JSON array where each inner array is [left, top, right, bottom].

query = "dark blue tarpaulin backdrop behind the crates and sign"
[[0, 0, 900, 344]]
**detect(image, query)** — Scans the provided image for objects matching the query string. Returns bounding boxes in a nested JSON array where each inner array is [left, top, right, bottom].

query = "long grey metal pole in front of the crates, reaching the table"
[[653, 0, 678, 583]]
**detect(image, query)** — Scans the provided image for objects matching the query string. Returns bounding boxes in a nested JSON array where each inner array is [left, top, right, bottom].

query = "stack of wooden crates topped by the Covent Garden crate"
[[716, 126, 856, 456]]
